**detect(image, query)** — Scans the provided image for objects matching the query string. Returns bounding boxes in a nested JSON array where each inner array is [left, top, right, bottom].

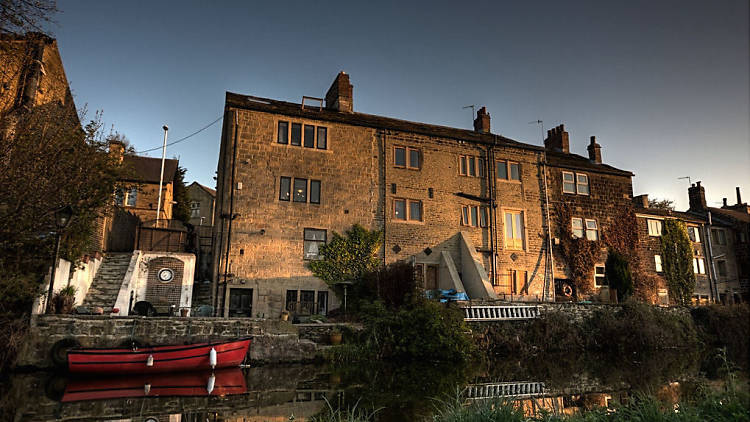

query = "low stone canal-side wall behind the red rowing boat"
[[16, 315, 360, 368]]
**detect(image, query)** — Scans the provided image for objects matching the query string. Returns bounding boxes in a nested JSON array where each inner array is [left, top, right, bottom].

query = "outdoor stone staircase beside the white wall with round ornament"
[[83, 253, 133, 312]]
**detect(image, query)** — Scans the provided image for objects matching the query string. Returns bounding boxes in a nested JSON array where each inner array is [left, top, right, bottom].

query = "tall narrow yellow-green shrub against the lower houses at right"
[[661, 219, 695, 305]]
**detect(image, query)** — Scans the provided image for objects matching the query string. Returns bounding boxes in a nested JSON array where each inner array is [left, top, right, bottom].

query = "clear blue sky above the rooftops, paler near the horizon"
[[52, 0, 750, 209]]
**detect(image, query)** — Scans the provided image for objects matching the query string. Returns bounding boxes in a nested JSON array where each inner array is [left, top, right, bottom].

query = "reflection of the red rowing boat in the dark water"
[[61, 368, 247, 402]]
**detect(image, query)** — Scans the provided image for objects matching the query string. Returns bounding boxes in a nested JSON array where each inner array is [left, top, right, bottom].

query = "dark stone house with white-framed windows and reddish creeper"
[[544, 125, 633, 300]]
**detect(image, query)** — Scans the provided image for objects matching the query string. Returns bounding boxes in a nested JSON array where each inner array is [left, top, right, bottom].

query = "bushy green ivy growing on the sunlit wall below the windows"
[[309, 224, 383, 295]]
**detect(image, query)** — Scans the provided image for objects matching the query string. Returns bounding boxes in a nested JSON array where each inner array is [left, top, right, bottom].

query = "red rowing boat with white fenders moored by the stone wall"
[[68, 338, 251, 374]]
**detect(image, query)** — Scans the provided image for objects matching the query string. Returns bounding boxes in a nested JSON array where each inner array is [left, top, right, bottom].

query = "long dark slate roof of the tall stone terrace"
[[226, 92, 633, 176]]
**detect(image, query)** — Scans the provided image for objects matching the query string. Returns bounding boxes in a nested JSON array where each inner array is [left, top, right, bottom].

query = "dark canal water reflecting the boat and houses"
[[0, 352, 748, 422]]
